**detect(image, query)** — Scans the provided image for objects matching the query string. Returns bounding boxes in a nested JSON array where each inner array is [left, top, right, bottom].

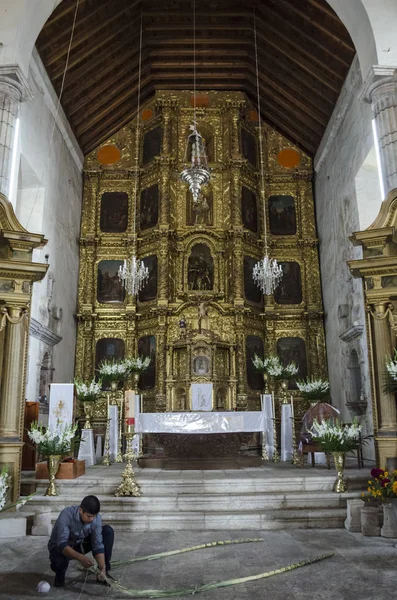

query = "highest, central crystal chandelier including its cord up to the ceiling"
[[181, 0, 211, 204]]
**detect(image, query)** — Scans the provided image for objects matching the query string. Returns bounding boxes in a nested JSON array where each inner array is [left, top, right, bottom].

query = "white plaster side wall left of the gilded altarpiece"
[[16, 52, 83, 401]]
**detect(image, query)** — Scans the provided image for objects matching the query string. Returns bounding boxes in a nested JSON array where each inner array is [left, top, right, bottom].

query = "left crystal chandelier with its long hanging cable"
[[118, 13, 149, 296]]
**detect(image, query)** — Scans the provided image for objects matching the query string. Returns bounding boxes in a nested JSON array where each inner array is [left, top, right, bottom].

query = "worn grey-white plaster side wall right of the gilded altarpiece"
[[314, 57, 374, 455]]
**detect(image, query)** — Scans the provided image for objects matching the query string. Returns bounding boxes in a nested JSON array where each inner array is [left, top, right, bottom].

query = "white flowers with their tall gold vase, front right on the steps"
[[310, 419, 363, 493]]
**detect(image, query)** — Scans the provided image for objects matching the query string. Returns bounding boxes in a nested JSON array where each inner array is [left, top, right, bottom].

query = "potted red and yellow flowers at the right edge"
[[362, 468, 397, 538]]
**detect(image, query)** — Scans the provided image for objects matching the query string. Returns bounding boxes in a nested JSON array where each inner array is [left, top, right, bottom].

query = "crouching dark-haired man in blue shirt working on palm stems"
[[48, 496, 114, 587]]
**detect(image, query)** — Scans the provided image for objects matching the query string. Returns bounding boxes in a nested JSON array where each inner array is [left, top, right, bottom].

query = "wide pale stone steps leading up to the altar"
[[22, 459, 369, 531]]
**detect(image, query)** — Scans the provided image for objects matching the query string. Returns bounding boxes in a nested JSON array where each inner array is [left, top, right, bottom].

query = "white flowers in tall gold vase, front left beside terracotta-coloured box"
[[28, 422, 77, 496]]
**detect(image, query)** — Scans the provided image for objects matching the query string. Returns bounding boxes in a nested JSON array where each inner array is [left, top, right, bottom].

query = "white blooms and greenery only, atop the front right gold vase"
[[310, 419, 362, 452]]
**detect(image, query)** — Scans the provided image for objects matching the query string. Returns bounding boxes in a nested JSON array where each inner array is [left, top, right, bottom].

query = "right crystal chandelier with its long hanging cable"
[[252, 15, 283, 296]]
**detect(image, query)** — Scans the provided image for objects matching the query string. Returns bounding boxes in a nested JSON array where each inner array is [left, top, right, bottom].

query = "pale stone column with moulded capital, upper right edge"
[[364, 65, 397, 196]]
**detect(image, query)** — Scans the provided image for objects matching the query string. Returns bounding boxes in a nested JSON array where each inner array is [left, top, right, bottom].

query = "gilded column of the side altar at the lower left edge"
[[0, 306, 28, 440]]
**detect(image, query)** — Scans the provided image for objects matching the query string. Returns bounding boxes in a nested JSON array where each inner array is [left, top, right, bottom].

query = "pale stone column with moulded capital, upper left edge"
[[0, 66, 29, 197]]
